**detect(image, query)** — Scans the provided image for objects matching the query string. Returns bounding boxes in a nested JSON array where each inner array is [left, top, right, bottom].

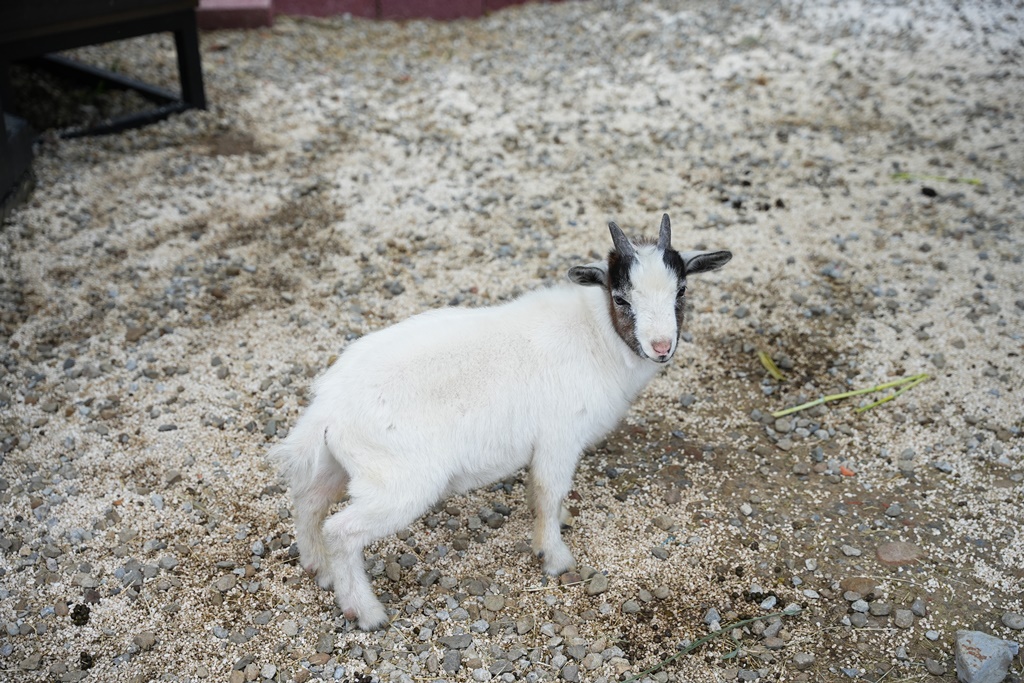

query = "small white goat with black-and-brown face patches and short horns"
[[273, 215, 732, 630]]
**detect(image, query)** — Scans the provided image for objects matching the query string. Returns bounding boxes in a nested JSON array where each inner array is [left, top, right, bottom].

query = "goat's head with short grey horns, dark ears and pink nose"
[[568, 214, 732, 362]]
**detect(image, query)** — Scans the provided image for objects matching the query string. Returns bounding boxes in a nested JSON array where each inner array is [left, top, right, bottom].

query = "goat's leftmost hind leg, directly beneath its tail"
[[292, 453, 348, 589]]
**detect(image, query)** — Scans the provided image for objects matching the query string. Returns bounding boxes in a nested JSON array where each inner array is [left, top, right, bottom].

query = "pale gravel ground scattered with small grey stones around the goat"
[[0, 0, 1024, 683]]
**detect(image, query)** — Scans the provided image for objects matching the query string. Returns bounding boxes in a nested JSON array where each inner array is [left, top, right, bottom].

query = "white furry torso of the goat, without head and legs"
[[308, 286, 656, 489]]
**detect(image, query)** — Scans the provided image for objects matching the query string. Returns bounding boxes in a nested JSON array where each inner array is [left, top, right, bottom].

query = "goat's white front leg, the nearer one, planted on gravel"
[[528, 451, 577, 577]]
